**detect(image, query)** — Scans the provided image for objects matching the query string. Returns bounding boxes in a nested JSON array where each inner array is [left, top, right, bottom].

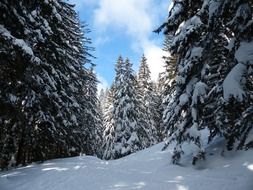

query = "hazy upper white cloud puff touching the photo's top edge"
[[95, 0, 152, 42]]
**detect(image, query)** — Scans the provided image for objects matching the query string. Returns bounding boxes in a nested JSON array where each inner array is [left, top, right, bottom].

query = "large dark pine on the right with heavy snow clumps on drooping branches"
[[157, 0, 252, 164]]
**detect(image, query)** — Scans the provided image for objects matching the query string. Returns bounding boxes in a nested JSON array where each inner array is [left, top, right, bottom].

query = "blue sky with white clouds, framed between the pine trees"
[[69, 0, 169, 89]]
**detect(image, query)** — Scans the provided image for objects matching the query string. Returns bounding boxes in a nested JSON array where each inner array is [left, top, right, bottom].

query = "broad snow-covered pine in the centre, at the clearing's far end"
[[103, 57, 150, 159]]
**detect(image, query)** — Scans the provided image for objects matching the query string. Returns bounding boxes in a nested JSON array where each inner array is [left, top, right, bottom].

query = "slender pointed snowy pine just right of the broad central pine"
[[137, 55, 161, 144]]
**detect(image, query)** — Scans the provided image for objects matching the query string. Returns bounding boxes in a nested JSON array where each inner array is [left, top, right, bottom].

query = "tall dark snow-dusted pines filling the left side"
[[0, 0, 95, 169]]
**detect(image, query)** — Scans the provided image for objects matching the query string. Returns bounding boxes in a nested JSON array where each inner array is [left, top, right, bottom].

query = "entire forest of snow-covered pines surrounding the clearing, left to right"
[[0, 0, 253, 169]]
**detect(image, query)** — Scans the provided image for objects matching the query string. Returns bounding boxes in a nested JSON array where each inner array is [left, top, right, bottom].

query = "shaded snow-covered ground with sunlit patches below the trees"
[[0, 141, 253, 190]]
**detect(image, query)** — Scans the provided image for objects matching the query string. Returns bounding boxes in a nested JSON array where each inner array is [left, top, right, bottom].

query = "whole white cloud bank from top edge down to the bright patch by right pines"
[[94, 0, 168, 80]]
